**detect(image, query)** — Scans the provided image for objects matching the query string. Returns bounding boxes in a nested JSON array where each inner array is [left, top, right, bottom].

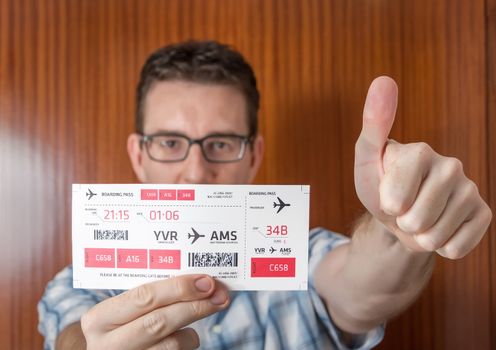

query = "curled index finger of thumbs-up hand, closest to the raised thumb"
[[379, 143, 432, 216]]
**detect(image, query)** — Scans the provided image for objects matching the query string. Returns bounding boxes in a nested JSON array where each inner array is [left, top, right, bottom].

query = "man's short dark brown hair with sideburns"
[[135, 41, 260, 136]]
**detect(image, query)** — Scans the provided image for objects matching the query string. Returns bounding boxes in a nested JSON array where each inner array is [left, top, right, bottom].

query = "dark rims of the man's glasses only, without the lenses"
[[140, 132, 253, 163]]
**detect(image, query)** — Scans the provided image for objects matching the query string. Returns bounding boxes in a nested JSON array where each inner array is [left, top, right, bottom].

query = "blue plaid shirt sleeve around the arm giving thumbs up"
[[308, 228, 385, 350]]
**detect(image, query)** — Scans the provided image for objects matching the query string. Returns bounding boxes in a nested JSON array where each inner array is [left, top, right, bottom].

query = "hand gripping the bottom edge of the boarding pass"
[[81, 275, 230, 350]]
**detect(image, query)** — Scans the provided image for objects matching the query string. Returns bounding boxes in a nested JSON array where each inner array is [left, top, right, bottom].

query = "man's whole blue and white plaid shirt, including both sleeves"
[[38, 228, 384, 350]]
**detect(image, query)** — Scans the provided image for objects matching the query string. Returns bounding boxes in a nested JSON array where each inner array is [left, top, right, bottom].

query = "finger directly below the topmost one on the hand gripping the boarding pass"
[[109, 285, 229, 349]]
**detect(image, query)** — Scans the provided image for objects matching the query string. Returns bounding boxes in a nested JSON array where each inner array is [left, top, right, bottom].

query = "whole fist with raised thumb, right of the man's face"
[[355, 77, 492, 259]]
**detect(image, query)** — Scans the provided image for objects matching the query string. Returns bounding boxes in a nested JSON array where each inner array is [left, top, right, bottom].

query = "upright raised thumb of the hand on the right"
[[356, 76, 398, 162]]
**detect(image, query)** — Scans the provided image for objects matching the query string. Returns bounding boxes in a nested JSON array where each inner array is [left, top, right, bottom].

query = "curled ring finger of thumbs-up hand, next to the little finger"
[[414, 181, 478, 252]]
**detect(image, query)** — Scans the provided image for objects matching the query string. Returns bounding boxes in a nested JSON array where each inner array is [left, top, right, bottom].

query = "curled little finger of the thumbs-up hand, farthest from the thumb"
[[437, 203, 492, 259]]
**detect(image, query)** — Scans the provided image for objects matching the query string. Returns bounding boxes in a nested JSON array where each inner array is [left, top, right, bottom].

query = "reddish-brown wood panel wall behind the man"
[[0, 0, 496, 349]]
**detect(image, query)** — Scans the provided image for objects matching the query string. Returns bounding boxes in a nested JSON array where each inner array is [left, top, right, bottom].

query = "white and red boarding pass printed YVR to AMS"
[[72, 184, 310, 290]]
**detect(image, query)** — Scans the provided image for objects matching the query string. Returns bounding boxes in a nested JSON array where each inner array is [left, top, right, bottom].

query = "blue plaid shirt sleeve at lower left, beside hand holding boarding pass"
[[38, 266, 118, 350]]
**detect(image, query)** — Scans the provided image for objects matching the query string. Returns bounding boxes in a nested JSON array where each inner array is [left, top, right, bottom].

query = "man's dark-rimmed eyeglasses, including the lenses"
[[141, 133, 252, 163]]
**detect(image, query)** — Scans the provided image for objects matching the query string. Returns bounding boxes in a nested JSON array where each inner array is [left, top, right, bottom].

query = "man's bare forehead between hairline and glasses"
[[144, 81, 248, 137]]
